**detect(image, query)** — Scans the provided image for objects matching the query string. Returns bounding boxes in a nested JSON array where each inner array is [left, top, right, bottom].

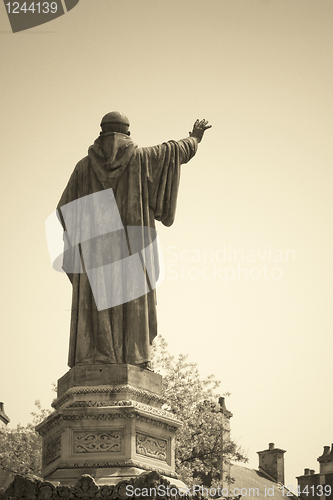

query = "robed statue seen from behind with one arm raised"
[[57, 112, 210, 367]]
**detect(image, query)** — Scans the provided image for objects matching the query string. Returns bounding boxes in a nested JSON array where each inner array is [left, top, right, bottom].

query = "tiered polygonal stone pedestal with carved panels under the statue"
[[36, 365, 181, 485]]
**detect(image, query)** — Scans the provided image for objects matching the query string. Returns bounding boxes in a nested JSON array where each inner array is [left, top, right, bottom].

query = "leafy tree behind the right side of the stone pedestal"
[[152, 336, 247, 485]]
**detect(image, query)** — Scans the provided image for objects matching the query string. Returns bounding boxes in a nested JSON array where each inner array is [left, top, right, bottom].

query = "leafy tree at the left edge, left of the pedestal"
[[0, 400, 50, 476]]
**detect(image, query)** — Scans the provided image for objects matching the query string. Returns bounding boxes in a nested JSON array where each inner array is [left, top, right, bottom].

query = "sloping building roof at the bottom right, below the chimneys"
[[227, 464, 298, 500]]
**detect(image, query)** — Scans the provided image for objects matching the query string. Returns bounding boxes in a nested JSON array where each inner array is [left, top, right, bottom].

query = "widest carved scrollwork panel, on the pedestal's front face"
[[73, 431, 123, 453]]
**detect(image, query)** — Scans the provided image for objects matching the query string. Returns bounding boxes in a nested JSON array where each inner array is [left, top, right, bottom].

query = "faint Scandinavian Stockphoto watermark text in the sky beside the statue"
[[165, 244, 296, 284]]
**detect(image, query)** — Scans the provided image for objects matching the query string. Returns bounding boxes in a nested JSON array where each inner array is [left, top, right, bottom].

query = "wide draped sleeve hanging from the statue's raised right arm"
[[140, 137, 198, 226]]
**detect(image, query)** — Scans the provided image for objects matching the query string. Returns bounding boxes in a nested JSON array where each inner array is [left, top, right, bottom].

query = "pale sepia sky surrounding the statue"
[[0, 0, 333, 487]]
